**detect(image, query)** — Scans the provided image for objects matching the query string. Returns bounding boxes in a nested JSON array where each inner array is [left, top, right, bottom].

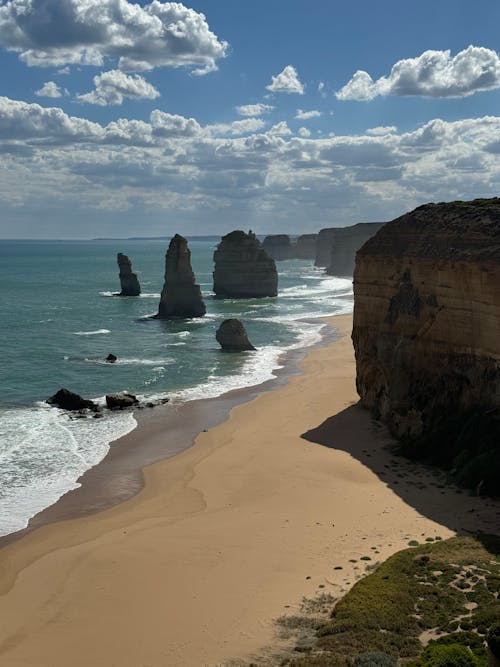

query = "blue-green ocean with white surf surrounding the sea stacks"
[[0, 238, 352, 535]]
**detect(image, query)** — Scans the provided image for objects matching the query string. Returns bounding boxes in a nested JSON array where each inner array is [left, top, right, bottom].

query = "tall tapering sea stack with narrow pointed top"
[[157, 234, 206, 318]]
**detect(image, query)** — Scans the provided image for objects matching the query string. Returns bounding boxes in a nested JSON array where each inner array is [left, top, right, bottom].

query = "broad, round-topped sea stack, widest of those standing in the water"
[[214, 231, 278, 298]]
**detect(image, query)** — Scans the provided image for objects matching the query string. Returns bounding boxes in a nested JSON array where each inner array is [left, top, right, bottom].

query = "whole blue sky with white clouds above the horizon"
[[0, 0, 500, 239]]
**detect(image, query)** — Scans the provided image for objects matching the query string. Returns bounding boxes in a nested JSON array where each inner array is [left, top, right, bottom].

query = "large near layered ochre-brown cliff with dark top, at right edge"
[[352, 199, 500, 438]]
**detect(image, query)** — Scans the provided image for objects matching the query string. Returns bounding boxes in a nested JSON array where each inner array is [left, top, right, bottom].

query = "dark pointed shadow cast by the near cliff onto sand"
[[301, 403, 500, 535]]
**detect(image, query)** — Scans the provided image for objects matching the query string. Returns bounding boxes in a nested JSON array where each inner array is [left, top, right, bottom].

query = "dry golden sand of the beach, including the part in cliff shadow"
[[0, 316, 500, 667]]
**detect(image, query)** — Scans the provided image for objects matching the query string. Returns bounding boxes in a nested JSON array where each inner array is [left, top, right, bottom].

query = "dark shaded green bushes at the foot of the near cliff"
[[397, 409, 500, 496]]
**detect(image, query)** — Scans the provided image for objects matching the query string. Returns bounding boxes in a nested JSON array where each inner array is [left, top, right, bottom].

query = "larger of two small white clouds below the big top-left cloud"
[[77, 69, 160, 106]]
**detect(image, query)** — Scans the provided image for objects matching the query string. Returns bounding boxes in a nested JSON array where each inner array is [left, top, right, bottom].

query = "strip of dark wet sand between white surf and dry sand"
[[0, 315, 343, 550]]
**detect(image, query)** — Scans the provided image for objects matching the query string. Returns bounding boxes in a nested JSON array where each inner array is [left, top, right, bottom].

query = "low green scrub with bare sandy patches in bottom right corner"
[[282, 535, 500, 667]]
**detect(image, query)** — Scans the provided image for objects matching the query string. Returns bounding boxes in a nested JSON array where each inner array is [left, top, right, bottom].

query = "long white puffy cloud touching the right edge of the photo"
[[336, 46, 500, 102]]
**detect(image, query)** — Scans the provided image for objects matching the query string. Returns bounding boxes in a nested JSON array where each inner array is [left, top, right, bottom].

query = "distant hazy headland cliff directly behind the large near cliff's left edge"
[[326, 222, 384, 276]]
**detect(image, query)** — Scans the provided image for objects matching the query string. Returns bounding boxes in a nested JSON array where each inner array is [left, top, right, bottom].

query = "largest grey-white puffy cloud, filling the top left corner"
[[0, 0, 228, 74]]
